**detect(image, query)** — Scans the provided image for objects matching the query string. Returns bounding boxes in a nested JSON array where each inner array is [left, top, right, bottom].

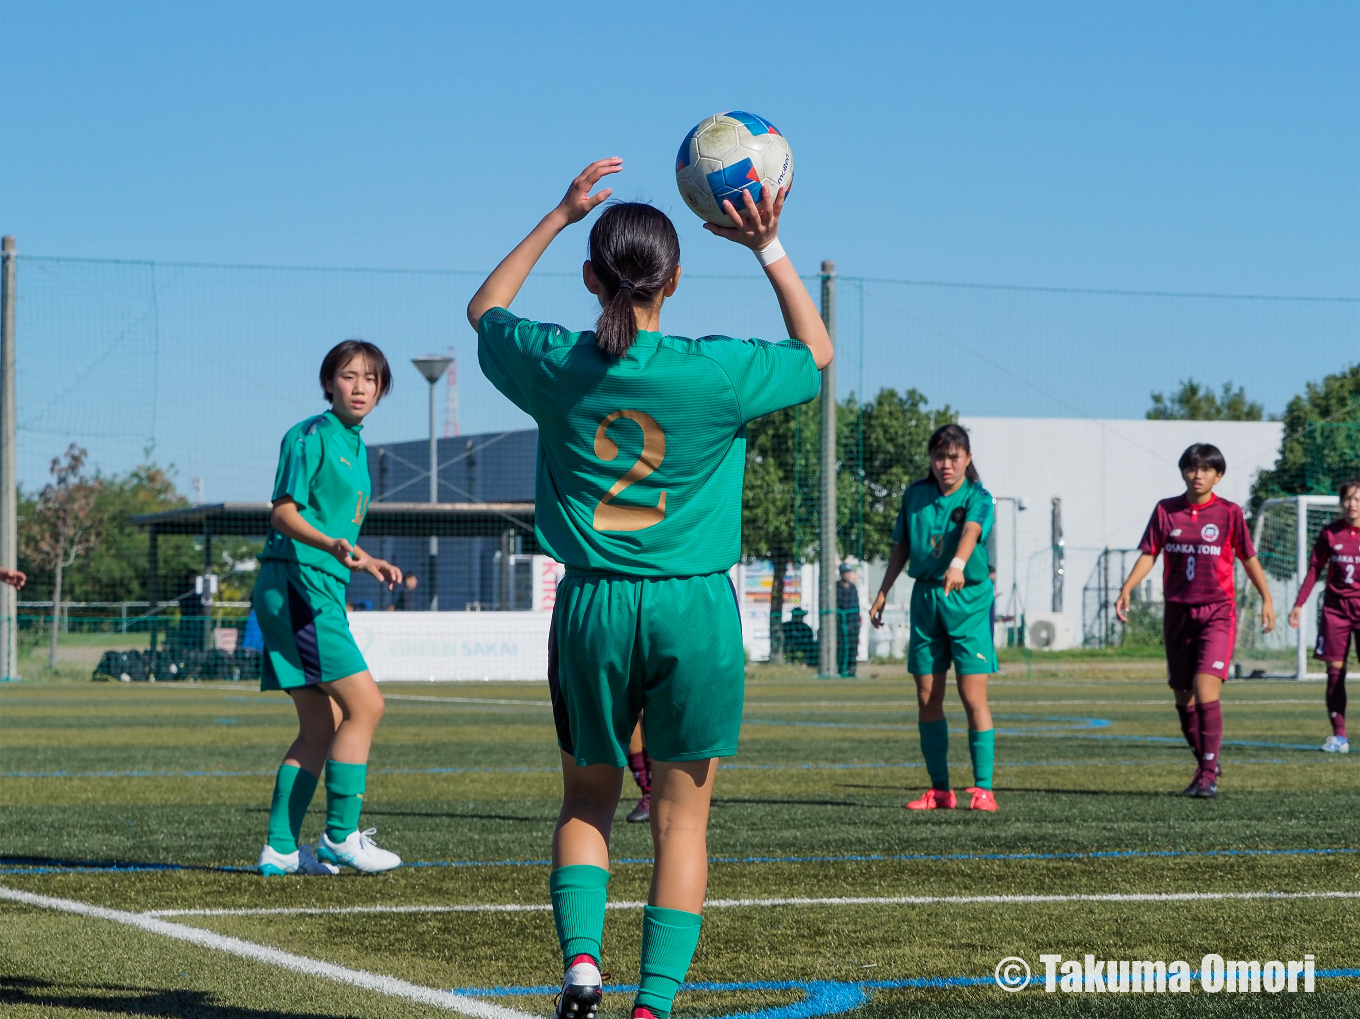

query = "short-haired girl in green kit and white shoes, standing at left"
[[252, 340, 401, 875]]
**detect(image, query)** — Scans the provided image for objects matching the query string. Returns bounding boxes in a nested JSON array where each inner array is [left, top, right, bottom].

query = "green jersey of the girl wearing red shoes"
[[892, 478, 993, 584]]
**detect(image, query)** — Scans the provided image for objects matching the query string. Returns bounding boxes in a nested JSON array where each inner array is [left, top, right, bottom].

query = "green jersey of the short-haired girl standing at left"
[[260, 411, 373, 581]]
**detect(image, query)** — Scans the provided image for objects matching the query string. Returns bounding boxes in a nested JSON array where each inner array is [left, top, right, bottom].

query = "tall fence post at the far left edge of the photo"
[[0, 237, 19, 682]]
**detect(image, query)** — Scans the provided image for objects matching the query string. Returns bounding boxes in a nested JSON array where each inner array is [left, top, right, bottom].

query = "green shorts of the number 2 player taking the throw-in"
[[548, 570, 745, 767]]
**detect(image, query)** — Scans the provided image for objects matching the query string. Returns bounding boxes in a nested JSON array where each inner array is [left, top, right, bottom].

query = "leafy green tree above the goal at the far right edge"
[[1251, 365, 1360, 510]]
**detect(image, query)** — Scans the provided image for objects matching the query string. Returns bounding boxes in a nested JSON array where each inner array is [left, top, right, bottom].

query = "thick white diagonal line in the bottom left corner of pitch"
[[0, 886, 534, 1019]]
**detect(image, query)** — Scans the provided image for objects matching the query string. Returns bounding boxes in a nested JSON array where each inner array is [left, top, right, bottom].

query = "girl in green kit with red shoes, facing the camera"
[[869, 424, 997, 811]]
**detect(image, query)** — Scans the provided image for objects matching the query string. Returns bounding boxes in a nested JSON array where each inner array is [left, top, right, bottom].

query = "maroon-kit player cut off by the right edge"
[[1289, 478, 1360, 754]]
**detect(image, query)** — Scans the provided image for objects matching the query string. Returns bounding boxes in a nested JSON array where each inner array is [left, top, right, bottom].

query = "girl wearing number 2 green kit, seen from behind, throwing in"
[[468, 159, 831, 1019]]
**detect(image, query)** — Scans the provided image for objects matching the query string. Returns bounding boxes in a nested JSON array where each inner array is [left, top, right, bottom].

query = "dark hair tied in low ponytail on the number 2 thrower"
[[590, 201, 680, 358]]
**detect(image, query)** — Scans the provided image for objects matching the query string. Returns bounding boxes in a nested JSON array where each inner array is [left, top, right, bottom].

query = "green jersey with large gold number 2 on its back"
[[477, 307, 820, 577]]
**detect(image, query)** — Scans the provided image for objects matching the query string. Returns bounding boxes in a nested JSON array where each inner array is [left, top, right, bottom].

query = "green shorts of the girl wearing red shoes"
[[907, 581, 997, 676]]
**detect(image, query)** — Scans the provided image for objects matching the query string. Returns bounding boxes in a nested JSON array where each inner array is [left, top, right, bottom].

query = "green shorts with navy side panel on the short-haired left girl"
[[252, 559, 369, 690]]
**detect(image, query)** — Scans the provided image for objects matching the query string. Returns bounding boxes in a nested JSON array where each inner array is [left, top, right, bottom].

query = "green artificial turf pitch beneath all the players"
[[0, 663, 1360, 1019]]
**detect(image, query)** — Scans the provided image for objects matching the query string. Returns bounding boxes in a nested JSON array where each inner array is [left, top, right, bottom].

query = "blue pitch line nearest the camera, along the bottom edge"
[[453, 969, 1360, 1019]]
